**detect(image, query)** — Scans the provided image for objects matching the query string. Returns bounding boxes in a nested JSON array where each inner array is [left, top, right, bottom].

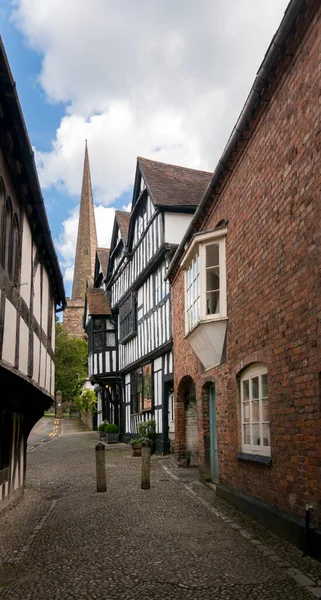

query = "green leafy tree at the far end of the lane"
[[55, 321, 88, 402]]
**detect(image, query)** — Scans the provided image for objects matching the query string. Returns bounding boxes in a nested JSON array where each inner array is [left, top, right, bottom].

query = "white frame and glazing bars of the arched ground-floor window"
[[240, 363, 271, 456]]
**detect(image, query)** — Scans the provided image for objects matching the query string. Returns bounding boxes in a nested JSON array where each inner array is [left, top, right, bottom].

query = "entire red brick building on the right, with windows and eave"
[[168, 0, 321, 552]]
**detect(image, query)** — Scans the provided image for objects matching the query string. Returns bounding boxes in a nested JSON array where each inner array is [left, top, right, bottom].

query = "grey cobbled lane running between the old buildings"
[[0, 419, 321, 600]]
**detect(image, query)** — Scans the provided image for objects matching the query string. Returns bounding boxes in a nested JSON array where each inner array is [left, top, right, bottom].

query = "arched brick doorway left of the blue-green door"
[[175, 375, 199, 467]]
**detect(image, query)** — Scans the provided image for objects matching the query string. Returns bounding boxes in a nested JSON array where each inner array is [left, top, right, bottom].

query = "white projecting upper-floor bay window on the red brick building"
[[181, 229, 226, 333]]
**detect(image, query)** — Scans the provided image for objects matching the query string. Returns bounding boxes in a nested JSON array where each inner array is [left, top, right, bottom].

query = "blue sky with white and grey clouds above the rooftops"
[[0, 0, 288, 296]]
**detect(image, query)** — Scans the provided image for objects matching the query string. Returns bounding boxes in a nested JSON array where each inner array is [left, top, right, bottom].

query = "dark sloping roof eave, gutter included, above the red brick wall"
[[167, 0, 320, 281]]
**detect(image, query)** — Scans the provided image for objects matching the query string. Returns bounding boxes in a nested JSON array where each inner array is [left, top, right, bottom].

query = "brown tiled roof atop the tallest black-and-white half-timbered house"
[[137, 156, 213, 207]]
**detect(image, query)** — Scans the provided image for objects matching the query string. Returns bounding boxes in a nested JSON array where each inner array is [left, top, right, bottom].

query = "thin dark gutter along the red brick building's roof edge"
[[166, 0, 306, 279]]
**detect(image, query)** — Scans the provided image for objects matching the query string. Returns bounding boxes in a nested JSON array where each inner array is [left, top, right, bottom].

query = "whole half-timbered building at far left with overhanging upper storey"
[[0, 40, 65, 510]]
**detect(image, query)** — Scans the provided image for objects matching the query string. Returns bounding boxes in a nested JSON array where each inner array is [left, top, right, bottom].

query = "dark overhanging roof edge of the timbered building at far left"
[[0, 37, 66, 308]]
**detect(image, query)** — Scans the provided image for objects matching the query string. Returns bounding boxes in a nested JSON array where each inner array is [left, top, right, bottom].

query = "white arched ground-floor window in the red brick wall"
[[241, 364, 271, 456]]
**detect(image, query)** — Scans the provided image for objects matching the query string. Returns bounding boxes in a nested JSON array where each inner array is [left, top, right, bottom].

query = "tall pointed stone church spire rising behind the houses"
[[72, 140, 97, 300]]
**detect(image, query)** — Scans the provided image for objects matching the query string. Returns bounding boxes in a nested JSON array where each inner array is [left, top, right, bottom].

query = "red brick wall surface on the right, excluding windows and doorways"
[[172, 8, 321, 524]]
